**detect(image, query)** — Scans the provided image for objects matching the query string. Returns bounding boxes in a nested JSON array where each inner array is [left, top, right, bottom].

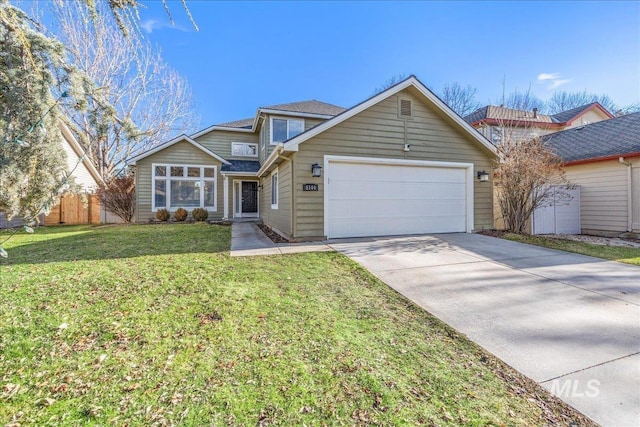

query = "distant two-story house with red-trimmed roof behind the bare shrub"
[[464, 102, 613, 144]]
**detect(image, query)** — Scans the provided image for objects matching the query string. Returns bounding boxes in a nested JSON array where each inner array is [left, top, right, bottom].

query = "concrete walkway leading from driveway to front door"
[[230, 222, 333, 256]]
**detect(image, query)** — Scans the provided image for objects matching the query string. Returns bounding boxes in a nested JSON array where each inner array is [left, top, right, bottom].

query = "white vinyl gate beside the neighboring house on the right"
[[531, 186, 581, 234]]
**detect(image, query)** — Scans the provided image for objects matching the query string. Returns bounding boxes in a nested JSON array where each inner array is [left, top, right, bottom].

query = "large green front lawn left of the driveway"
[[0, 224, 588, 426]]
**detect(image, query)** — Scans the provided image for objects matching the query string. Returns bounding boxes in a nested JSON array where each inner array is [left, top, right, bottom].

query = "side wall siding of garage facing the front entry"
[[260, 161, 295, 237]]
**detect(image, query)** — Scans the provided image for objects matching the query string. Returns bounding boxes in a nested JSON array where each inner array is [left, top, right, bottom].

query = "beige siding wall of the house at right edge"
[[566, 160, 628, 233]]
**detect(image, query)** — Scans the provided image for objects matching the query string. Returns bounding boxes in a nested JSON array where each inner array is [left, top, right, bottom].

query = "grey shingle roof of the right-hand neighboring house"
[[542, 113, 640, 162]]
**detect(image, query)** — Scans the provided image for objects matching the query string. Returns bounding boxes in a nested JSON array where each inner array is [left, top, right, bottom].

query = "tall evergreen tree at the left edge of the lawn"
[[0, 0, 82, 223]]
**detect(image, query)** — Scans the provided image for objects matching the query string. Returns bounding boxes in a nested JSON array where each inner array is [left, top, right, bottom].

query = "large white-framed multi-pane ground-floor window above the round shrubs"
[[152, 165, 217, 212]]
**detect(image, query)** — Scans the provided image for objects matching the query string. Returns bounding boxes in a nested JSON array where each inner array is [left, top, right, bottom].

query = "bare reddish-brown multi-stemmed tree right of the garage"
[[494, 125, 571, 234]]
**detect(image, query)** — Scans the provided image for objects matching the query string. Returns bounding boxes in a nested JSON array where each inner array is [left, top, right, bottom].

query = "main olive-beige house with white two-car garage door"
[[130, 76, 496, 241]]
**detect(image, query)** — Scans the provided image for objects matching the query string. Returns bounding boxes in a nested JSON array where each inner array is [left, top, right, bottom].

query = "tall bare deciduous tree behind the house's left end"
[[53, 2, 198, 179]]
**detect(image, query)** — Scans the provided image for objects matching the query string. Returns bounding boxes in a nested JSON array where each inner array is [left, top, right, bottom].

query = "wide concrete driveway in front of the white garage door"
[[329, 234, 640, 426]]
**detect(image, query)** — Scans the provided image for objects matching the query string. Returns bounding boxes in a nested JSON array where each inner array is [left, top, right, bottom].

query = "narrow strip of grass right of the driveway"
[[503, 233, 640, 265]]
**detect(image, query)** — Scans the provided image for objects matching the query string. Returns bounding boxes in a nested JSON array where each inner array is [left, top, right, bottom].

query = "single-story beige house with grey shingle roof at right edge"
[[543, 113, 640, 235]]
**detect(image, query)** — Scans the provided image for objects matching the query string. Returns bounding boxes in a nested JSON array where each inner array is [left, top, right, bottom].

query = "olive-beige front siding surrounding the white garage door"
[[280, 90, 493, 240]]
